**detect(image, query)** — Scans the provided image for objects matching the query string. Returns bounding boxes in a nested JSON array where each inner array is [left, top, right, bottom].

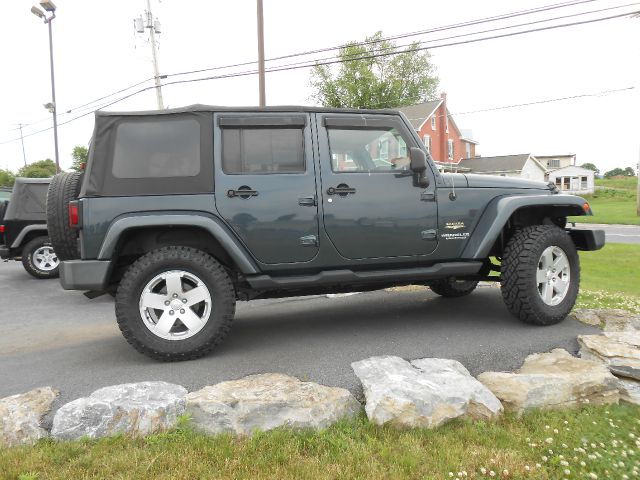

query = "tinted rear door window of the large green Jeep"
[[222, 128, 305, 175]]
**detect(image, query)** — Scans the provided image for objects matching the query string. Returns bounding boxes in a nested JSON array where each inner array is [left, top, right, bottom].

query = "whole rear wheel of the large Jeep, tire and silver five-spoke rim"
[[116, 246, 235, 361]]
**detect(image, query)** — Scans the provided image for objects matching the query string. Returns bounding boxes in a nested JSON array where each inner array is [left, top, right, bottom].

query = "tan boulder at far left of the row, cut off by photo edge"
[[0, 387, 58, 447]]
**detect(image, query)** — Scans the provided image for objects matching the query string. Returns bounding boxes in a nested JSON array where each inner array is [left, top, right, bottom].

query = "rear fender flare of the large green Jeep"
[[98, 211, 260, 274]]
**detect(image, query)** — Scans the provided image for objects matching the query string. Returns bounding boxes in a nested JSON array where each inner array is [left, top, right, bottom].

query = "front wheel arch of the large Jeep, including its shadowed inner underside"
[[462, 195, 593, 259]]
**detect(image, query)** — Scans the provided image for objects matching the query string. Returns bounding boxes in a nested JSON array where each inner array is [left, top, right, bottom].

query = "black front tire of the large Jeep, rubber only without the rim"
[[500, 225, 580, 325]]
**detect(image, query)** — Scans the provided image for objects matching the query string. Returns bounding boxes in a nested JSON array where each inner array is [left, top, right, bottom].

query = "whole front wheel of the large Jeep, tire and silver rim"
[[500, 225, 580, 325]]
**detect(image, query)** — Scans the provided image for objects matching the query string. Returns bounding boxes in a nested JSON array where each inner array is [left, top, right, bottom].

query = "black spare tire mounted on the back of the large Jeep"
[[47, 172, 83, 260]]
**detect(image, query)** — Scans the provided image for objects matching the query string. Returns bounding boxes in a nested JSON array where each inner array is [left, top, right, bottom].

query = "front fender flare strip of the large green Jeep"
[[462, 195, 592, 259]]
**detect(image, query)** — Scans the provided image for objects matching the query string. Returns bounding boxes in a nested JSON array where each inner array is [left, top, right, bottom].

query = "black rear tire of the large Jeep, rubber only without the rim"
[[116, 246, 236, 362]]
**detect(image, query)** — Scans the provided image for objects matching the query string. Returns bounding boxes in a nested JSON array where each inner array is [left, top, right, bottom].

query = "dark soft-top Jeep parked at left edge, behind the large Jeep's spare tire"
[[0, 177, 59, 278]]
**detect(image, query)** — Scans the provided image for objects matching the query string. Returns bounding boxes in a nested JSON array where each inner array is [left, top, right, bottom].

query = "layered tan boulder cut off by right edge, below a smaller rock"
[[578, 331, 640, 369]]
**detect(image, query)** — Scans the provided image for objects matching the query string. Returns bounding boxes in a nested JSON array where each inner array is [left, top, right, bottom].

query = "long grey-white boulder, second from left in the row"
[[51, 382, 187, 440]]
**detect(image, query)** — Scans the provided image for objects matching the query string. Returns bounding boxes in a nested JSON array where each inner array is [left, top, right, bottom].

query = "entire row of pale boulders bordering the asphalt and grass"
[[0, 310, 640, 447]]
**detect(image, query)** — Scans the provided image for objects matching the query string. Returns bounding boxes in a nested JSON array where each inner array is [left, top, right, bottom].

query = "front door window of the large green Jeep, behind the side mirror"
[[327, 127, 411, 173]]
